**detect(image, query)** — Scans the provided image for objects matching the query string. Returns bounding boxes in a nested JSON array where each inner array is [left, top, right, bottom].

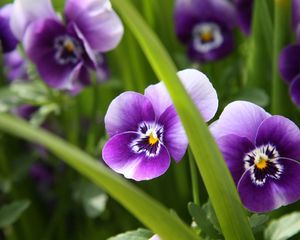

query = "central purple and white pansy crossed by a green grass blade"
[[102, 69, 218, 181]]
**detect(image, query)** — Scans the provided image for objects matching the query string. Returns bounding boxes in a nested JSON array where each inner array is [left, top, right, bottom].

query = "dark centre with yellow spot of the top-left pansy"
[[54, 35, 82, 65]]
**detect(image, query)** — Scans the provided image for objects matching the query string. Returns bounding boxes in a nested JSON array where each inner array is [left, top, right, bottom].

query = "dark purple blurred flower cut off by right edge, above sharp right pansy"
[[279, 44, 300, 107]]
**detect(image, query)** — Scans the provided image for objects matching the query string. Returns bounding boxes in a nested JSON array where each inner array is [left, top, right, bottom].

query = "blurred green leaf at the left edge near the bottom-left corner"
[[0, 200, 30, 228]]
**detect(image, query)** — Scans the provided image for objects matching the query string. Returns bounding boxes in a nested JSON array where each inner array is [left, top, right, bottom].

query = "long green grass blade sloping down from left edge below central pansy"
[[0, 114, 199, 240]]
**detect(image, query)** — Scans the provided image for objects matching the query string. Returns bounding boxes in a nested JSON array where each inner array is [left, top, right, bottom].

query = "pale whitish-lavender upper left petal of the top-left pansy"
[[10, 0, 58, 40]]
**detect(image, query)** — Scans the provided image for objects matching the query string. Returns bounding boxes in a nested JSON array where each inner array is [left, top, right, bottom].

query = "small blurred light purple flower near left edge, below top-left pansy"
[[3, 49, 28, 82]]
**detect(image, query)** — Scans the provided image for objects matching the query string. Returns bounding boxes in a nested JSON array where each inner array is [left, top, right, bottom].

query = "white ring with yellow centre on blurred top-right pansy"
[[193, 22, 223, 52]]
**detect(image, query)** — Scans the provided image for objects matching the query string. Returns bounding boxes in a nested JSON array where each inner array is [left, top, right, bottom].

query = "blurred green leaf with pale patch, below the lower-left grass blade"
[[74, 181, 108, 218]]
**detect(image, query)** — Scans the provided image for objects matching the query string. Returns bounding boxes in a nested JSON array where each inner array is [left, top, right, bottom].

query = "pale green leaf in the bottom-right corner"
[[265, 212, 300, 240]]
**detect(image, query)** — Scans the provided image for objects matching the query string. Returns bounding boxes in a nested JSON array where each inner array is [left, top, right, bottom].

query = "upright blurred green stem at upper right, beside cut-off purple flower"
[[271, 0, 292, 115]]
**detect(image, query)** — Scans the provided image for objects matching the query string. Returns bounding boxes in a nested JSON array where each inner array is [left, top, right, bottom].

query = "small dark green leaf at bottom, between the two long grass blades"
[[188, 203, 222, 239]]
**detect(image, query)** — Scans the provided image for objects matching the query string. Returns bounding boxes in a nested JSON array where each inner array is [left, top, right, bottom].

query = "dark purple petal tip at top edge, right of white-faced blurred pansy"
[[235, 0, 254, 35]]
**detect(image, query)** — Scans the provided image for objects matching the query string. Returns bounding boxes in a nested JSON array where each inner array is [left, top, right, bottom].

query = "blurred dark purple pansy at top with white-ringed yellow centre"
[[174, 0, 236, 62]]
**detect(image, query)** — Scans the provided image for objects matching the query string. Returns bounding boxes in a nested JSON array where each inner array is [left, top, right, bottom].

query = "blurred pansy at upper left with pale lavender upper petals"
[[11, 0, 123, 93]]
